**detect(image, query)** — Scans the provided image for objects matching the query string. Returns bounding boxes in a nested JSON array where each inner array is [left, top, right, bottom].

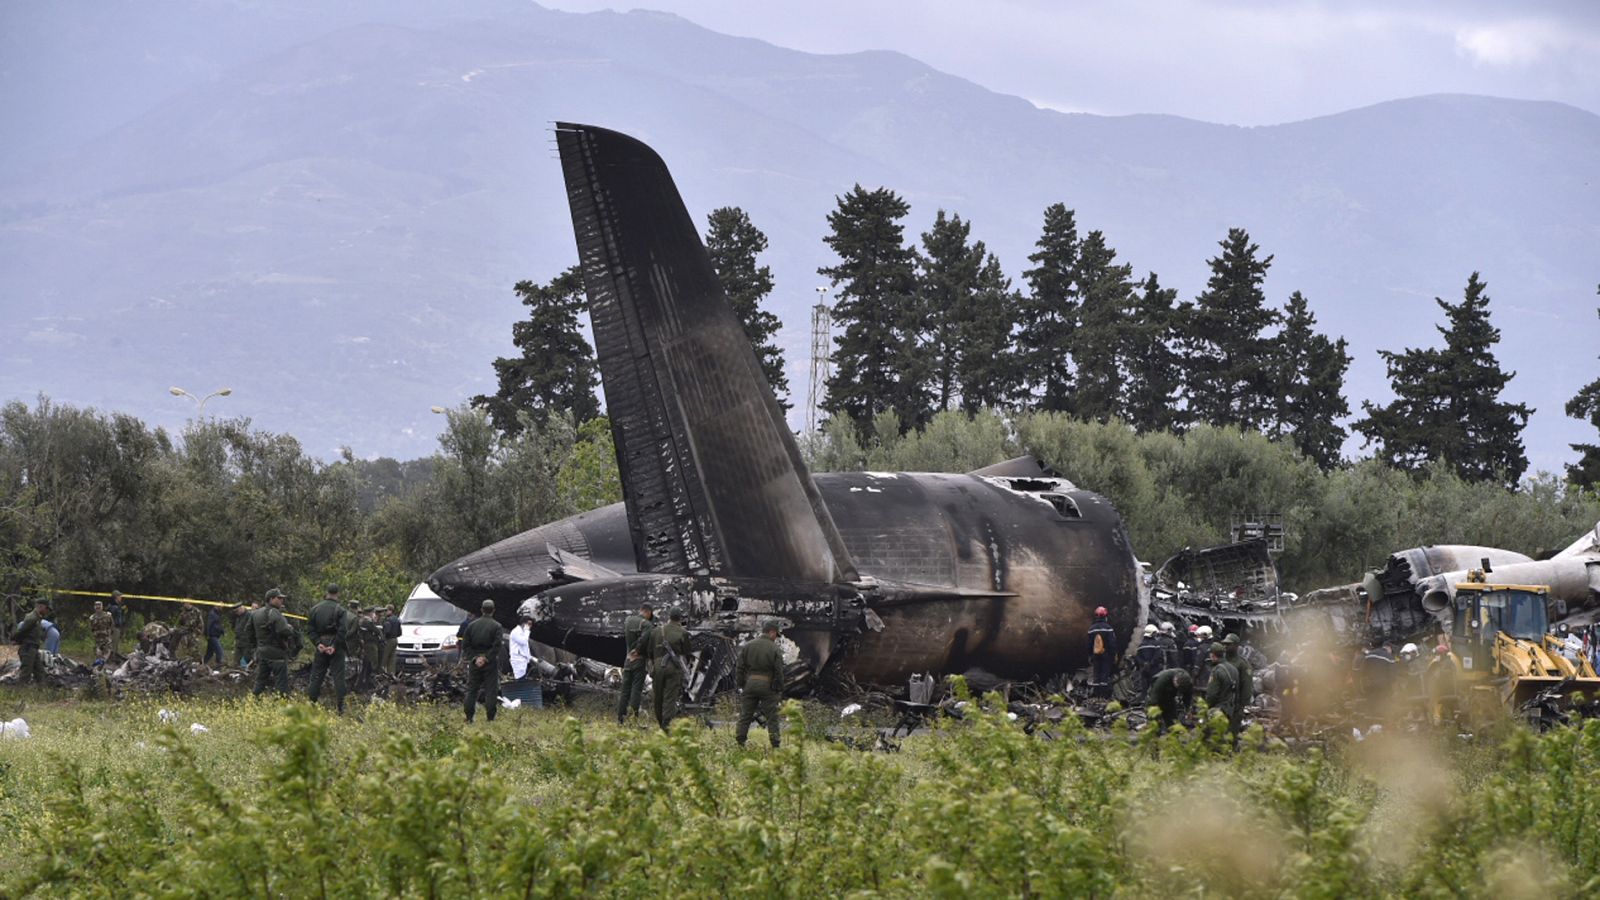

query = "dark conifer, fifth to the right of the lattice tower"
[[1067, 231, 1133, 421]]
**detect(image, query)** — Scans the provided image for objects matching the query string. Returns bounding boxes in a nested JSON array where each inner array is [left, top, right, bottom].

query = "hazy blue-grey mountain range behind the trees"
[[0, 0, 1600, 469]]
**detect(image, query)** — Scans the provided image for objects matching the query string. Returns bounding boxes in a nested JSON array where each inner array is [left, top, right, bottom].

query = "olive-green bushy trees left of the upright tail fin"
[[0, 397, 621, 621]]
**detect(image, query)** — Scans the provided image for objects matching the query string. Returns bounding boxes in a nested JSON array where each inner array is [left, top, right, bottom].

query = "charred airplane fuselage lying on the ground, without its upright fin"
[[430, 472, 1144, 684]]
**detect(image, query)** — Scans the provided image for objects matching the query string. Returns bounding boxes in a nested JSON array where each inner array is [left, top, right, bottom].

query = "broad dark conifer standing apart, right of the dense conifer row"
[[1355, 272, 1533, 485]]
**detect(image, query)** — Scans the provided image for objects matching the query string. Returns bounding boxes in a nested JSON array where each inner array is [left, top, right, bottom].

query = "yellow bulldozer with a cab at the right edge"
[[1451, 570, 1600, 727]]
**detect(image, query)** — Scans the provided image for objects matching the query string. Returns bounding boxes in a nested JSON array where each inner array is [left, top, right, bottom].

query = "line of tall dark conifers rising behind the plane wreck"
[[486, 200, 1600, 487]]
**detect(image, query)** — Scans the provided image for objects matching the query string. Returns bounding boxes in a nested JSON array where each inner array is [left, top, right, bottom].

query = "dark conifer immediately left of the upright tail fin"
[[472, 266, 600, 437]]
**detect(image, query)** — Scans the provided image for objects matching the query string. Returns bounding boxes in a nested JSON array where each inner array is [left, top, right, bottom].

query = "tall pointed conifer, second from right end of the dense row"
[[1182, 227, 1278, 429]]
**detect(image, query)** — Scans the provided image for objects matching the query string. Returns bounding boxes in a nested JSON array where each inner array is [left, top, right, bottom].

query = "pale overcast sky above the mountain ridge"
[[539, 0, 1600, 125]]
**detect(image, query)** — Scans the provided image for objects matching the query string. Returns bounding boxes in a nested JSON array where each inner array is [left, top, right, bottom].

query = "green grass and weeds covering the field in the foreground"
[[0, 695, 1600, 897]]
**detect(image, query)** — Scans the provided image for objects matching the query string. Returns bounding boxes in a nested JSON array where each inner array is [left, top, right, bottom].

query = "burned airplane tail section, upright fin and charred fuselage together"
[[429, 123, 1147, 697]]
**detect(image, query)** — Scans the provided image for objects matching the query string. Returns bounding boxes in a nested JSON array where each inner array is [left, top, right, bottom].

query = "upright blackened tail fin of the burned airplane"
[[555, 123, 856, 581]]
